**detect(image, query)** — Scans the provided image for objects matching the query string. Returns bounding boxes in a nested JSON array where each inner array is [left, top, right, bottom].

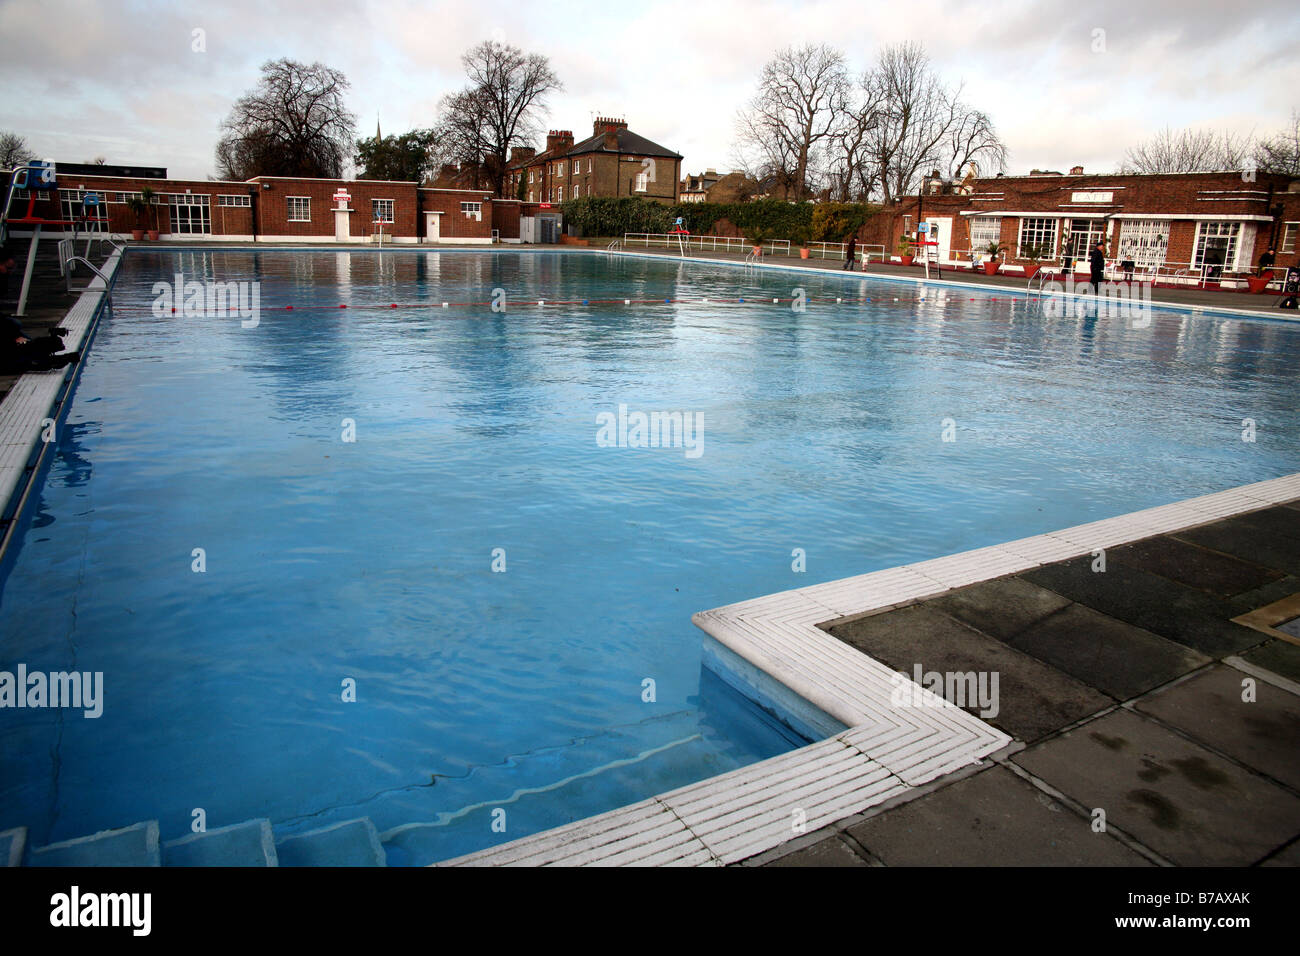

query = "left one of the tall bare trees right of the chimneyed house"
[[737, 44, 850, 199]]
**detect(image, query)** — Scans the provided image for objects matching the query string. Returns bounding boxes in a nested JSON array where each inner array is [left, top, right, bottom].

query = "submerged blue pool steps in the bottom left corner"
[[8, 817, 387, 866]]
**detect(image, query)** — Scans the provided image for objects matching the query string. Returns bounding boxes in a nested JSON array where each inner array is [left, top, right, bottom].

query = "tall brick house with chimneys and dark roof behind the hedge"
[[507, 117, 681, 203]]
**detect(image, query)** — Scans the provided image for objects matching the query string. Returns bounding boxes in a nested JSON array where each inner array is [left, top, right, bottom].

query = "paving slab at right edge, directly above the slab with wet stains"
[[1134, 665, 1300, 790]]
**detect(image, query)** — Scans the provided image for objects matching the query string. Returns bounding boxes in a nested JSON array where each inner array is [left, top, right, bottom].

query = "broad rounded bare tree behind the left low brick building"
[[217, 59, 356, 179]]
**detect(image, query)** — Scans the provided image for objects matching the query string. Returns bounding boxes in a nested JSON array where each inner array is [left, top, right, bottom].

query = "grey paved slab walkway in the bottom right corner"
[[746, 501, 1300, 866]]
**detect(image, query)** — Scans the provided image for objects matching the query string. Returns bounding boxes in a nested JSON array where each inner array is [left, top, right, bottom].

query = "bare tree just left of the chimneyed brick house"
[[437, 40, 564, 196]]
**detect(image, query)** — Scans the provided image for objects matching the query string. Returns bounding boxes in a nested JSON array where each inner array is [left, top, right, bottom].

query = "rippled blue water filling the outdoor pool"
[[0, 250, 1300, 864]]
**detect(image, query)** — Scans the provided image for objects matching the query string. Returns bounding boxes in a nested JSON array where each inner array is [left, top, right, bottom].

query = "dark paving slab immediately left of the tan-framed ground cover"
[[1022, 557, 1261, 657]]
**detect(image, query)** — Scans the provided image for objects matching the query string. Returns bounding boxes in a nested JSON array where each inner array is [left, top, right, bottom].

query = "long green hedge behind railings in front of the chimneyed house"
[[560, 196, 880, 242]]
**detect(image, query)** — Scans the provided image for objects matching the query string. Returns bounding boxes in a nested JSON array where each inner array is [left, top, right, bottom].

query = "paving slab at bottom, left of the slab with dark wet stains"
[[848, 767, 1151, 866]]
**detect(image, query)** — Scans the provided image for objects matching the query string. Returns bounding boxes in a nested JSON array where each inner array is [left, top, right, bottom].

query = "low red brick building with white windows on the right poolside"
[[863, 166, 1300, 278]]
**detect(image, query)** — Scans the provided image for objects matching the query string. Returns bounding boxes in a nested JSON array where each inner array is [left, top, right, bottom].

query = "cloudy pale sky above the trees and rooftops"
[[0, 0, 1300, 179]]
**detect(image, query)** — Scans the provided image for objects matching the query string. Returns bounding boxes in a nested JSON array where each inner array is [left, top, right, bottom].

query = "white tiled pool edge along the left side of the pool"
[[0, 250, 122, 553]]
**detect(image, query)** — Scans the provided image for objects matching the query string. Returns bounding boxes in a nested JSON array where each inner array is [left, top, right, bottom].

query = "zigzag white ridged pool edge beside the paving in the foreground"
[[447, 472, 1300, 866]]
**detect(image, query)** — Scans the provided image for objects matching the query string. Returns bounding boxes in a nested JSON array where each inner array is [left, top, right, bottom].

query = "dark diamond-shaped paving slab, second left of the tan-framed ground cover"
[[1011, 605, 1209, 700]]
